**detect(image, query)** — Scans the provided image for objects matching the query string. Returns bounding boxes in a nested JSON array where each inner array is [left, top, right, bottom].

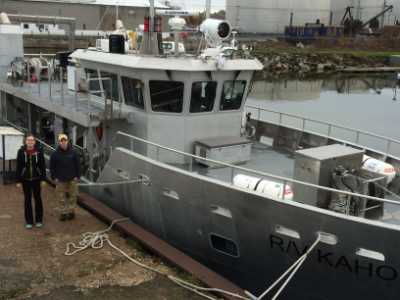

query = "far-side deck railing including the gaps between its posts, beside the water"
[[245, 105, 400, 160]]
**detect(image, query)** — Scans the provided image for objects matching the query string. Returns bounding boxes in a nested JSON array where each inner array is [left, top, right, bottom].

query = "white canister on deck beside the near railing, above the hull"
[[233, 174, 293, 200]]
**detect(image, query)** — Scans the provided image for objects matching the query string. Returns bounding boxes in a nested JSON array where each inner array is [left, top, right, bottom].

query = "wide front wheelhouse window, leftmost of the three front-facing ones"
[[149, 80, 185, 113]]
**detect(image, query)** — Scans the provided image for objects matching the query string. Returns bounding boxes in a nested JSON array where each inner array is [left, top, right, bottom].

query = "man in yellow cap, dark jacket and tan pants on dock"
[[50, 134, 80, 221]]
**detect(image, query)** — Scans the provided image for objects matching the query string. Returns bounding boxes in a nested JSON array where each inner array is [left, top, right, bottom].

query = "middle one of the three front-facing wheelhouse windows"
[[190, 81, 217, 113]]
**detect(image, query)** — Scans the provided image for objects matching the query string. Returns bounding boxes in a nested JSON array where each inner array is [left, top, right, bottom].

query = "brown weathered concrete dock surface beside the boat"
[[0, 185, 203, 300]]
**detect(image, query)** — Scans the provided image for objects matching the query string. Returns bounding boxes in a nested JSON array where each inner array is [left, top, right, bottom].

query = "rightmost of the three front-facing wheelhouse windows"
[[220, 80, 247, 110]]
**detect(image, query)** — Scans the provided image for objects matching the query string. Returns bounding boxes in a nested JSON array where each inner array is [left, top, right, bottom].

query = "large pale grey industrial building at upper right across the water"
[[226, 0, 400, 34]]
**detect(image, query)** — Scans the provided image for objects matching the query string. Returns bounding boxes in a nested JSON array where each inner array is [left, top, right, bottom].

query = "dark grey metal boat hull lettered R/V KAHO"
[[79, 148, 400, 300]]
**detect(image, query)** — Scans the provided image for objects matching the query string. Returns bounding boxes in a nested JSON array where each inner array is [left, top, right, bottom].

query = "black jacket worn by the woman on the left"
[[17, 145, 46, 182]]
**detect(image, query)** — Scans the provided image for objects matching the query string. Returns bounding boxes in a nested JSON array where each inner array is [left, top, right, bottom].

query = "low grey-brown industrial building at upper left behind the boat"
[[0, 0, 168, 30]]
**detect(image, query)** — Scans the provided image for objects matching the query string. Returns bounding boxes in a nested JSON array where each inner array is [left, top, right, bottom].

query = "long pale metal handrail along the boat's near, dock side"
[[116, 131, 400, 206]]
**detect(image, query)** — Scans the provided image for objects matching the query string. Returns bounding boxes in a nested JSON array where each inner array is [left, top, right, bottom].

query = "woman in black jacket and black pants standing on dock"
[[17, 134, 46, 229]]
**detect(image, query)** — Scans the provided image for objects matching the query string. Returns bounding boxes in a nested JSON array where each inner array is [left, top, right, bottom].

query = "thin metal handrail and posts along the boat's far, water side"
[[246, 105, 400, 156]]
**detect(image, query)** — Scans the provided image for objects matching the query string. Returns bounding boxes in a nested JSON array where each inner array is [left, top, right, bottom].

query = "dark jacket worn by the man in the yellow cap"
[[50, 147, 81, 182]]
